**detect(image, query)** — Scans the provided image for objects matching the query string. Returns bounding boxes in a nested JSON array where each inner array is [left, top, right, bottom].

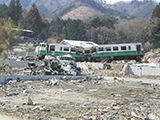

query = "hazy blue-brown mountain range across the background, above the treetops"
[[0, 0, 157, 19]]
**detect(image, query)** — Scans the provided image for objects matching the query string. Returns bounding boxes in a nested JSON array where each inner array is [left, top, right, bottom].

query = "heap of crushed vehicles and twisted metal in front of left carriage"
[[24, 55, 81, 76]]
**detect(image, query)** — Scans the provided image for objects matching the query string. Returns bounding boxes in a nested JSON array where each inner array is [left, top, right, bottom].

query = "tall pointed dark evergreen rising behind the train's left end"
[[26, 4, 45, 37]]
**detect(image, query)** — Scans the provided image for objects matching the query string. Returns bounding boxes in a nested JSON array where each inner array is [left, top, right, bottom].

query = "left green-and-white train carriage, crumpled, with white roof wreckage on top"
[[35, 40, 98, 61]]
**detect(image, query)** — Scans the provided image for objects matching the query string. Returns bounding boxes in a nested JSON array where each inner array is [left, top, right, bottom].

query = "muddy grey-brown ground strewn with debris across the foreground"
[[0, 63, 160, 120]]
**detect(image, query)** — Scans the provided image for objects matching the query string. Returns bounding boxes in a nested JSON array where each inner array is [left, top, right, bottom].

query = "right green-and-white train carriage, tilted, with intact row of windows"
[[91, 43, 144, 61]]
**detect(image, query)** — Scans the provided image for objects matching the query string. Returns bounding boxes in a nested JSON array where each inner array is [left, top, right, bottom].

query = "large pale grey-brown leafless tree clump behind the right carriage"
[[115, 18, 149, 43]]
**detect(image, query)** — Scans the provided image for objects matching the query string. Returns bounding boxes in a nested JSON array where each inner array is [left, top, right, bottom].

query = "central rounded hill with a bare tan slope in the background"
[[48, 0, 132, 20]]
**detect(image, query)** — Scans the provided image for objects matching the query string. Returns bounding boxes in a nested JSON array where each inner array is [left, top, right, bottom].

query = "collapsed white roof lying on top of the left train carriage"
[[60, 40, 98, 49]]
